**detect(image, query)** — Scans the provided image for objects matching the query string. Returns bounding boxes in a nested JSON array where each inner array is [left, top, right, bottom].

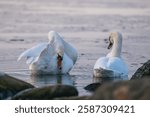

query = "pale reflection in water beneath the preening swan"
[[31, 74, 74, 87]]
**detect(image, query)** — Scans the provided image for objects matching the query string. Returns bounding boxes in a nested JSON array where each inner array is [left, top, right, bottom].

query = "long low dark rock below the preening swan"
[[12, 85, 78, 100]]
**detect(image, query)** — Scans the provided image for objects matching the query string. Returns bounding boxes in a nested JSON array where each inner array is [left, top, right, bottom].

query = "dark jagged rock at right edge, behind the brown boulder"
[[131, 60, 150, 80]]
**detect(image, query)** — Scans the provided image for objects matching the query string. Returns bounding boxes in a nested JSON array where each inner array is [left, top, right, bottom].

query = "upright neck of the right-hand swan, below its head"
[[107, 38, 122, 57]]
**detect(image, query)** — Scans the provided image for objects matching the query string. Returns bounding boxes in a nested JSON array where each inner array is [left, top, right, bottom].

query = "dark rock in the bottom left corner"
[[0, 73, 34, 99]]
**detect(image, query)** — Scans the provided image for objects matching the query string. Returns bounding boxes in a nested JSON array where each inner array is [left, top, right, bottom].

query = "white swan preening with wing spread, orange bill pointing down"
[[18, 31, 78, 75]]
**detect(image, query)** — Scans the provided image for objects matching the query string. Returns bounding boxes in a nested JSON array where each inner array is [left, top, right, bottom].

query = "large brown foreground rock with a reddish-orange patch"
[[89, 79, 150, 100]]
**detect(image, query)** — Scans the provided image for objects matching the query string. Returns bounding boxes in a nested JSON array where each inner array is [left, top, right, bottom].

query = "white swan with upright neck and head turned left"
[[93, 32, 128, 79]]
